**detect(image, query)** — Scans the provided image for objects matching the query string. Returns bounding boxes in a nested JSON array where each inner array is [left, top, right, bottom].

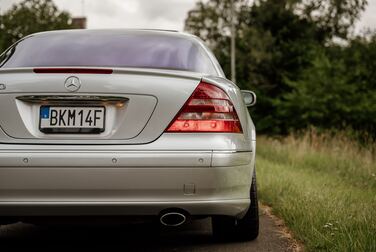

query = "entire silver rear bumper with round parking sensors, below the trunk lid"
[[0, 151, 254, 216]]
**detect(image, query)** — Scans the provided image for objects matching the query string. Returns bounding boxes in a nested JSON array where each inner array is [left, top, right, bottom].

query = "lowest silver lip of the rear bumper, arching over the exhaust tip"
[[0, 199, 250, 217]]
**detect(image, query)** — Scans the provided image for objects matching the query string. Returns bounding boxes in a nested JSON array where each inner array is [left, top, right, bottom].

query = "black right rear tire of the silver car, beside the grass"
[[212, 170, 259, 241]]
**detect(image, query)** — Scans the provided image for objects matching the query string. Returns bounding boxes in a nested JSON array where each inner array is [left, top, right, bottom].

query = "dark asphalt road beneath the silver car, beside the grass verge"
[[0, 209, 292, 252]]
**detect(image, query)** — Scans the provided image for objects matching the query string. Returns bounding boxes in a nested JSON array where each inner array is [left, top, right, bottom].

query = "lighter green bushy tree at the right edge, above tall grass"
[[279, 38, 376, 137]]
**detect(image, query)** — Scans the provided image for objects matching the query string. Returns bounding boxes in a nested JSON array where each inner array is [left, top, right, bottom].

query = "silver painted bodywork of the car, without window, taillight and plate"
[[0, 31, 256, 218]]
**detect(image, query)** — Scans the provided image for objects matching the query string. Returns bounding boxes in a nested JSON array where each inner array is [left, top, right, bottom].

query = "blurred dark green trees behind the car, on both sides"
[[0, 0, 376, 138]]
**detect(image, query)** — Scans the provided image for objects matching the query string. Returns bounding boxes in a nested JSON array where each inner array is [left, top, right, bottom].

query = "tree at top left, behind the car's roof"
[[0, 0, 74, 52]]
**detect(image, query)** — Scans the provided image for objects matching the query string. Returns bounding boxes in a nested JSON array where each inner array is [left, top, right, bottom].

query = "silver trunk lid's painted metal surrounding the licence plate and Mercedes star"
[[0, 69, 200, 144]]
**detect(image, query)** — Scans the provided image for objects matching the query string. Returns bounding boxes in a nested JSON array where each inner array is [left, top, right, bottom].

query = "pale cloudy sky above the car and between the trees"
[[0, 0, 376, 33]]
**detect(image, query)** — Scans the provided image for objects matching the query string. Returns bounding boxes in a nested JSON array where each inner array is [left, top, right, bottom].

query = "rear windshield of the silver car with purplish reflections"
[[0, 31, 217, 75]]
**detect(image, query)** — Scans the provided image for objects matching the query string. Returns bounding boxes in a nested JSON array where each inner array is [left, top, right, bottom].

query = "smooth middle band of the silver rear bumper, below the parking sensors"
[[0, 154, 251, 202]]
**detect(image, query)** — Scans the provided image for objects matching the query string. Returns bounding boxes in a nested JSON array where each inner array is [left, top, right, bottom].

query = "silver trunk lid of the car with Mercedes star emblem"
[[0, 68, 201, 144]]
